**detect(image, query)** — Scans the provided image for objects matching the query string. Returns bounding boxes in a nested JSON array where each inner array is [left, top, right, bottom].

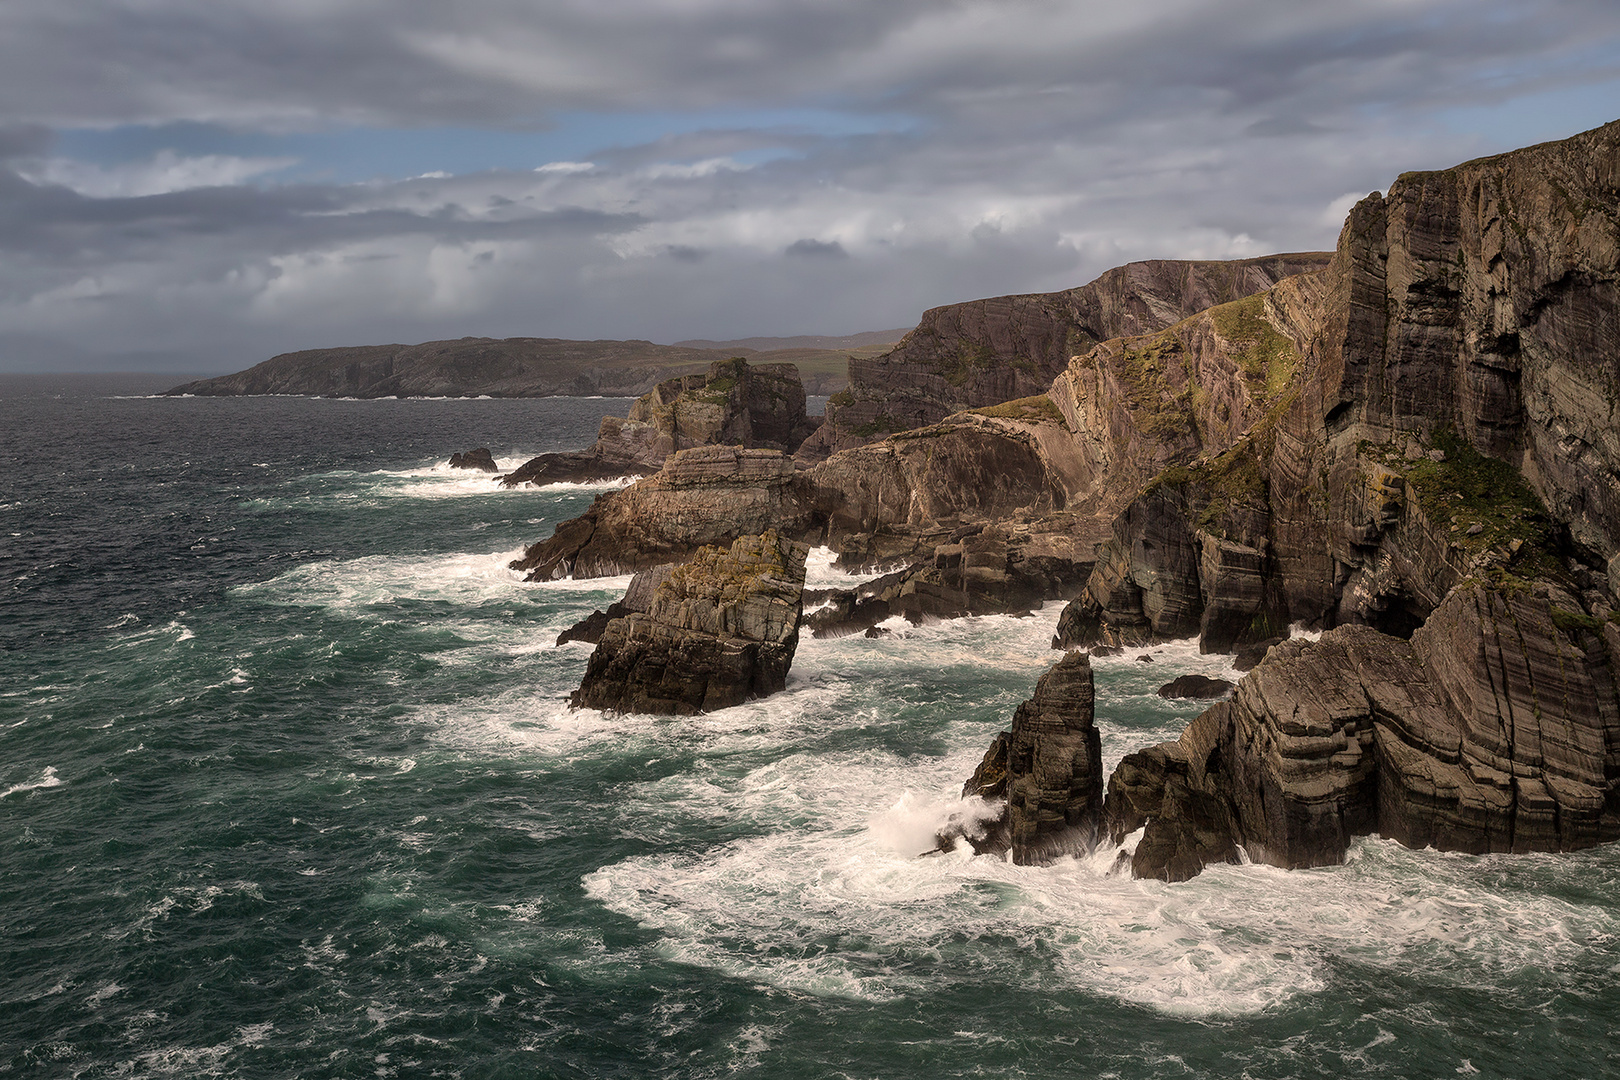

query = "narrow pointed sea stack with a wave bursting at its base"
[[941, 653, 1103, 866]]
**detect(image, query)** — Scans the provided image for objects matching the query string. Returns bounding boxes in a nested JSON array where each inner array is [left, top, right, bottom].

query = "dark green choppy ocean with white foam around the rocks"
[[0, 376, 1620, 1080]]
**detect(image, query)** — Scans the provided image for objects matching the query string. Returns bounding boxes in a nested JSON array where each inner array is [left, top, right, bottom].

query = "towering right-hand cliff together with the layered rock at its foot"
[[1059, 123, 1620, 879]]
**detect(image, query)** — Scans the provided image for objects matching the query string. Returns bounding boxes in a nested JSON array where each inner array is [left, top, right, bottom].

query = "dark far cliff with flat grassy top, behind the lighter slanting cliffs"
[[799, 253, 1328, 461]]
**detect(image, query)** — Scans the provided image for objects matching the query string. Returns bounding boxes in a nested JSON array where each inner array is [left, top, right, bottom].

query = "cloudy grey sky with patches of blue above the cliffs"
[[0, 0, 1620, 372]]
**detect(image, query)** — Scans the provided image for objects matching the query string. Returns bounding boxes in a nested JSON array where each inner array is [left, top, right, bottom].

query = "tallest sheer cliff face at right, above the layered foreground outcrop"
[[1053, 125, 1620, 649]]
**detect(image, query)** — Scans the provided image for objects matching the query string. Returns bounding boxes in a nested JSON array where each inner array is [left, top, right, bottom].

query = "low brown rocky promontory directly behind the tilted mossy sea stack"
[[512, 403, 1105, 595]]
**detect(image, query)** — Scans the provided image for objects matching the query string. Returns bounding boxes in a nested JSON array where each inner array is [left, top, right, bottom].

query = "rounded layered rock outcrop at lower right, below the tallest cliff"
[[1103, 585, 1620, 879]]
